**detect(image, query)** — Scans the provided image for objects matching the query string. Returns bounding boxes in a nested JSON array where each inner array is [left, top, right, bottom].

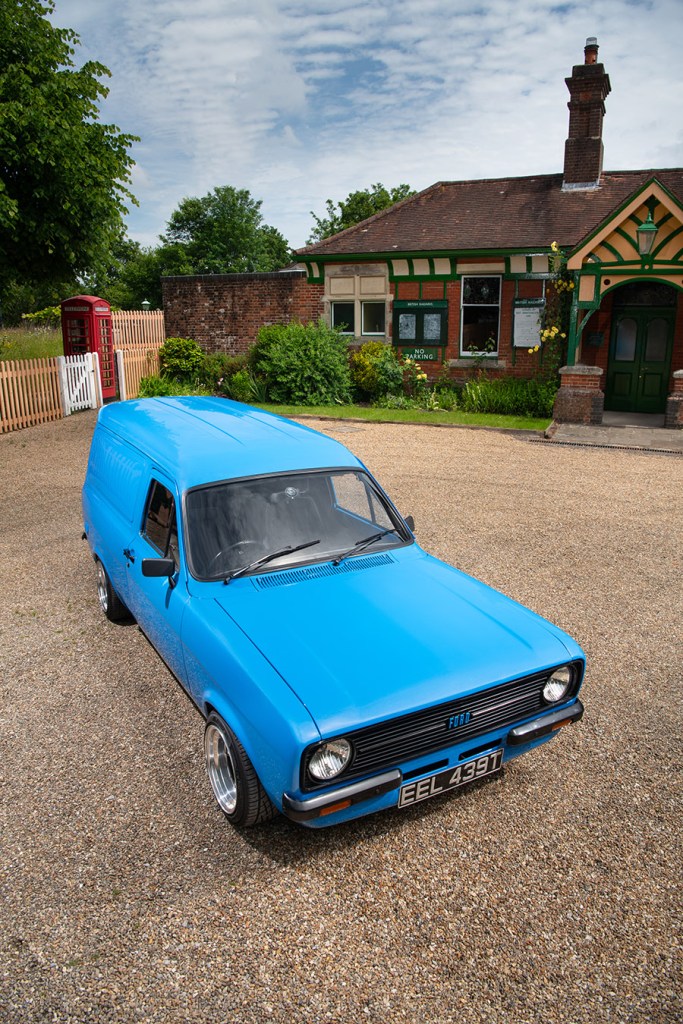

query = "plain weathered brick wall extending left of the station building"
[[162, 270, 323, 355]]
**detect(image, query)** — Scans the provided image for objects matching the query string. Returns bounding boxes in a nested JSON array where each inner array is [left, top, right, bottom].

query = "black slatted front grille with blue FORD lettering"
[[301, 663, 581, 790]]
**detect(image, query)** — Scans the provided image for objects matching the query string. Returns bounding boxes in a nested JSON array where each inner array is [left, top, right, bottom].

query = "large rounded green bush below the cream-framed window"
[[250, 319, 351, 406]]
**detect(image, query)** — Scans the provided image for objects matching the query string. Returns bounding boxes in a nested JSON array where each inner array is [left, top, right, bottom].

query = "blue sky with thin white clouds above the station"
[[51, 0, 683, 247]]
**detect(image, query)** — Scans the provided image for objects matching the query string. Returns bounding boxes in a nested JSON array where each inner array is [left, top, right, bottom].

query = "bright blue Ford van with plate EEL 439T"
[[78, 397, 585, 826]]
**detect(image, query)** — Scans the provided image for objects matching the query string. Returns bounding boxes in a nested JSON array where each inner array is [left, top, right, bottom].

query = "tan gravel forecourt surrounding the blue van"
[[0, 413, 683, 1024]]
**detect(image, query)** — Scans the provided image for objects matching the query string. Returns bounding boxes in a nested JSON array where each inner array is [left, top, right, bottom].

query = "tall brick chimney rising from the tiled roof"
[[562, 37, 611, 189]]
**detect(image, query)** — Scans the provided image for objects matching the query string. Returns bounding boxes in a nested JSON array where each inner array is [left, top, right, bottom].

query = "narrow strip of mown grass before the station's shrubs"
[[258, 402, 551, 430]]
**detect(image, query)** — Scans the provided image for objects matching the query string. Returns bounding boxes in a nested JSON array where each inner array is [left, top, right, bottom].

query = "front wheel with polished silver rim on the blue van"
[[204, 712, 276, 828]]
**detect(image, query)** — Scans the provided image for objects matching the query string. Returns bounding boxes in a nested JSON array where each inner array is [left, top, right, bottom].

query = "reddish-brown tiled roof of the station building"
[[298, 168, 683, 256]]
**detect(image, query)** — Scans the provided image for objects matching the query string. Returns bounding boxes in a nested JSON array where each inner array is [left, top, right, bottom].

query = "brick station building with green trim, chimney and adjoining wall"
[[164, 39, 683, 426]]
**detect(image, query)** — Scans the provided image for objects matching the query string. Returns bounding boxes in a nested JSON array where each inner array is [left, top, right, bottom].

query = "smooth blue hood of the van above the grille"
[[217, 545, 581, 735]]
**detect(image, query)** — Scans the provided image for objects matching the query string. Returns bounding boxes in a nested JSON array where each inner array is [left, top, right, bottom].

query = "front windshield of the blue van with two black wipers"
[[185, 469, 405, 581]]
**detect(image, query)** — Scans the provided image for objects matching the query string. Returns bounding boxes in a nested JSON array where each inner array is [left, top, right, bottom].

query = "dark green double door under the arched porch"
[[605, 307, 674, 413]]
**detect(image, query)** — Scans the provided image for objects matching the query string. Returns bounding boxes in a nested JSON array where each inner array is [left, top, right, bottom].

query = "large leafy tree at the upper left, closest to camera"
[[0, 0, 137, 292]]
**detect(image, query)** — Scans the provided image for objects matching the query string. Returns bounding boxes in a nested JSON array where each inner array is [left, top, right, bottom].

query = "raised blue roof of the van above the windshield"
[[98, 396, 361, 490]]
